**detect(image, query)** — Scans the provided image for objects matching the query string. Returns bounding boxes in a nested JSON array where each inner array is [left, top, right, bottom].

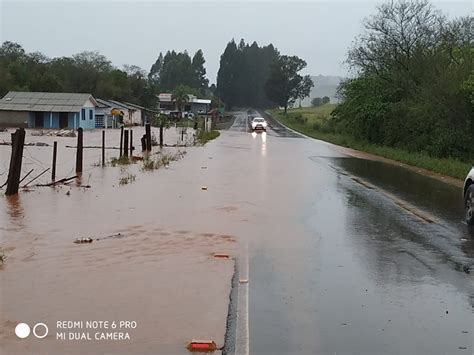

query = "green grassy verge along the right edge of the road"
[[269, 104, 471, 180]]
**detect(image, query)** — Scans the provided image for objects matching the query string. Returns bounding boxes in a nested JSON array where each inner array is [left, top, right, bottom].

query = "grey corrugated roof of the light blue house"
[[0, 91, 97, 112]]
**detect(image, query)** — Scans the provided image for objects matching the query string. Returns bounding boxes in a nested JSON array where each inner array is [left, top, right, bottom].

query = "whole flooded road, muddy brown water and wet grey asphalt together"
[[0, 113, 474, 355]]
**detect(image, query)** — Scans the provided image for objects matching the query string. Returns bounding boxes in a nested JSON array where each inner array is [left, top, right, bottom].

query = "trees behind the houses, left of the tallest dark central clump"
[[0, 41, 211, 108]]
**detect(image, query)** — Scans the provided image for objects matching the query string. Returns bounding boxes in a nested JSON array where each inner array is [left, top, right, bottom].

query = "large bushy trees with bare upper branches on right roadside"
[[331, 0, 474, 160]]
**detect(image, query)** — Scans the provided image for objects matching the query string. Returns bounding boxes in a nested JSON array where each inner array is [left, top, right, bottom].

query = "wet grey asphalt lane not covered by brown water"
[[230, 114, 474, 354]]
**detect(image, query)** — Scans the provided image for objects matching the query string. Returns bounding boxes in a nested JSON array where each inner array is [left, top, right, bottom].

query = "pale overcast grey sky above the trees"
[[0, 0, 473, 82]]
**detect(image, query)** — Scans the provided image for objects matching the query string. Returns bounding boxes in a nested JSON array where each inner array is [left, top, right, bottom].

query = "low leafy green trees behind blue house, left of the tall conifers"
[[0, 42, 158, 107]]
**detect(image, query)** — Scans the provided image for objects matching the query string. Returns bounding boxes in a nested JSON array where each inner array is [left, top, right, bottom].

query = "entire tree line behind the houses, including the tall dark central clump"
[[0, 40, 313, 110]]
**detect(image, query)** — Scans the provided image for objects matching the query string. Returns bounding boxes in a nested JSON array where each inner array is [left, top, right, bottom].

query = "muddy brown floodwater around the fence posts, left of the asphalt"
[[0, 127, 239, 354]]
